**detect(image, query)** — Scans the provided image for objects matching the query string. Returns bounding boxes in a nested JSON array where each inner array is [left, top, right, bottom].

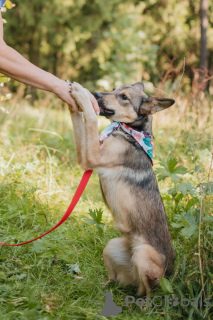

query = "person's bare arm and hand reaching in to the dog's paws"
[[0, 10, 99, 112]]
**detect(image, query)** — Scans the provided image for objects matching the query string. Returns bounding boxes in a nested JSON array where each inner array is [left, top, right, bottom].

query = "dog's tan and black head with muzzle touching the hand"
[[94, 82, 175, 134]]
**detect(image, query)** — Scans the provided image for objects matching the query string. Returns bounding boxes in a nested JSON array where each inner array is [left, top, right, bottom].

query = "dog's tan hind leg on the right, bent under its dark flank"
[[132, 244, 164, 295]]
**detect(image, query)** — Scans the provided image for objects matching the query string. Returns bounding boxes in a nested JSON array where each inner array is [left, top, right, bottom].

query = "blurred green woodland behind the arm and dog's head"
[[0, 0, 213, 100]]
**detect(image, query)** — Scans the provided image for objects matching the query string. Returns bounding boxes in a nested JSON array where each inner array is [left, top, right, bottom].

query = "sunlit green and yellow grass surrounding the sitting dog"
[[0, 91, 213, 320]]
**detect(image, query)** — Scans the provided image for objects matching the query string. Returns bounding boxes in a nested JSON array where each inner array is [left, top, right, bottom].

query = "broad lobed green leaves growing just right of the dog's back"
[[155, 154, 212, 249]]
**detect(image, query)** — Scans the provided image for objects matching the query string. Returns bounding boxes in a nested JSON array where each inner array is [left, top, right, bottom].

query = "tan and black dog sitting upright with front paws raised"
[[71, 82, 175, 296]]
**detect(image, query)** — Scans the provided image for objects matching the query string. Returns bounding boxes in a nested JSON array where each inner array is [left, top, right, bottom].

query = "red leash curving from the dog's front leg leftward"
[[0, 170, 92, 247]]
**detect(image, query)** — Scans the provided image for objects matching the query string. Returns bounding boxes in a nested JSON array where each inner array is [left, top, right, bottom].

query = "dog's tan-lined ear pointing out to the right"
[[140, 97, 175, 114]]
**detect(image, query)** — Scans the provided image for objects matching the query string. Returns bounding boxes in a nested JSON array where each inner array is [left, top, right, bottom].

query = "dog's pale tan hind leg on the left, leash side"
[[103, 237, 135, 285]]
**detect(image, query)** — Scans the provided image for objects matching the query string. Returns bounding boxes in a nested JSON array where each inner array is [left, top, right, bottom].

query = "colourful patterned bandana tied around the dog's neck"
[[99, 121, 154, 165]]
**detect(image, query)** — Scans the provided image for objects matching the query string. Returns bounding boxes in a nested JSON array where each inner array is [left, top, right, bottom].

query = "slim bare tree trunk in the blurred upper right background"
[[199, 0, 208, 90]]
